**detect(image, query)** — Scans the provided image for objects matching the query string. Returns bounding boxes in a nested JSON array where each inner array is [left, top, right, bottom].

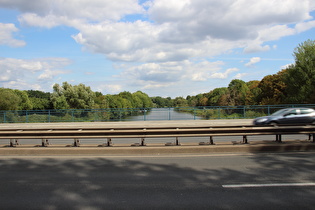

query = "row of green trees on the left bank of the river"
[[0, 82, 153, 110]]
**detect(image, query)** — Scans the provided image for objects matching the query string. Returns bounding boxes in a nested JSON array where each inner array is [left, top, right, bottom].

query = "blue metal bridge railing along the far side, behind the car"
[[0, 104, 315, 123]]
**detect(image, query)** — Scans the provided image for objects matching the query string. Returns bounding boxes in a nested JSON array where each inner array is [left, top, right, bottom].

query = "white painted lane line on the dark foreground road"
[[222, 182, 315, 188]]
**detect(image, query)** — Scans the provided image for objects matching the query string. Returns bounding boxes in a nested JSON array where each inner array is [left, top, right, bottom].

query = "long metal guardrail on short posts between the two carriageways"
[[0, 125, 315, 146]]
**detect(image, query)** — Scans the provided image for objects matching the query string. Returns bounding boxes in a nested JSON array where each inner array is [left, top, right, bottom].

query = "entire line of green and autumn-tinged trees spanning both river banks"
[[0, 40, 315, 110]]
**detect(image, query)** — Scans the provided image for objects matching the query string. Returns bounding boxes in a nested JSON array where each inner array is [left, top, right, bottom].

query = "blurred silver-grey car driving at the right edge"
[[253, 108, 315, 125]]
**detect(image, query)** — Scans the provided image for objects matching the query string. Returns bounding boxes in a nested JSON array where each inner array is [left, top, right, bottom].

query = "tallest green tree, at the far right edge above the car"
[[285, 40, 315, 103]]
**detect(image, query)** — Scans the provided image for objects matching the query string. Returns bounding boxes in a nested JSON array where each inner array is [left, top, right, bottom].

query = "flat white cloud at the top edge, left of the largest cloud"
[[11, 0, 144, 27]]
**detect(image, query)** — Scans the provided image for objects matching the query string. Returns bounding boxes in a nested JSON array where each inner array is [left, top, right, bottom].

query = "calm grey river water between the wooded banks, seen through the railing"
[[126, 108, 203, 121]]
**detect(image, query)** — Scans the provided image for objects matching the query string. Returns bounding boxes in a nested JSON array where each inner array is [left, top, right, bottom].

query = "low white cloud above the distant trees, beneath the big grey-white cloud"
[[112, 60, 239, 95]]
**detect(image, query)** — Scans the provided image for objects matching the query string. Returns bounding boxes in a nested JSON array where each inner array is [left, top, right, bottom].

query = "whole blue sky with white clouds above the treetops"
[[0, 0, 315, 98]]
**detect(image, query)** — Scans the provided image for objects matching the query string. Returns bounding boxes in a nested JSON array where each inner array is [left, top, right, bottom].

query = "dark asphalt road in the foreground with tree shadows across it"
[[0, 152, 315, 210]]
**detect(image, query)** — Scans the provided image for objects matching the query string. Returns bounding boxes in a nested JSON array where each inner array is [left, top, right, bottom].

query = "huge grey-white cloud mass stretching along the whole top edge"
[[0, 0, 315, 62]]
